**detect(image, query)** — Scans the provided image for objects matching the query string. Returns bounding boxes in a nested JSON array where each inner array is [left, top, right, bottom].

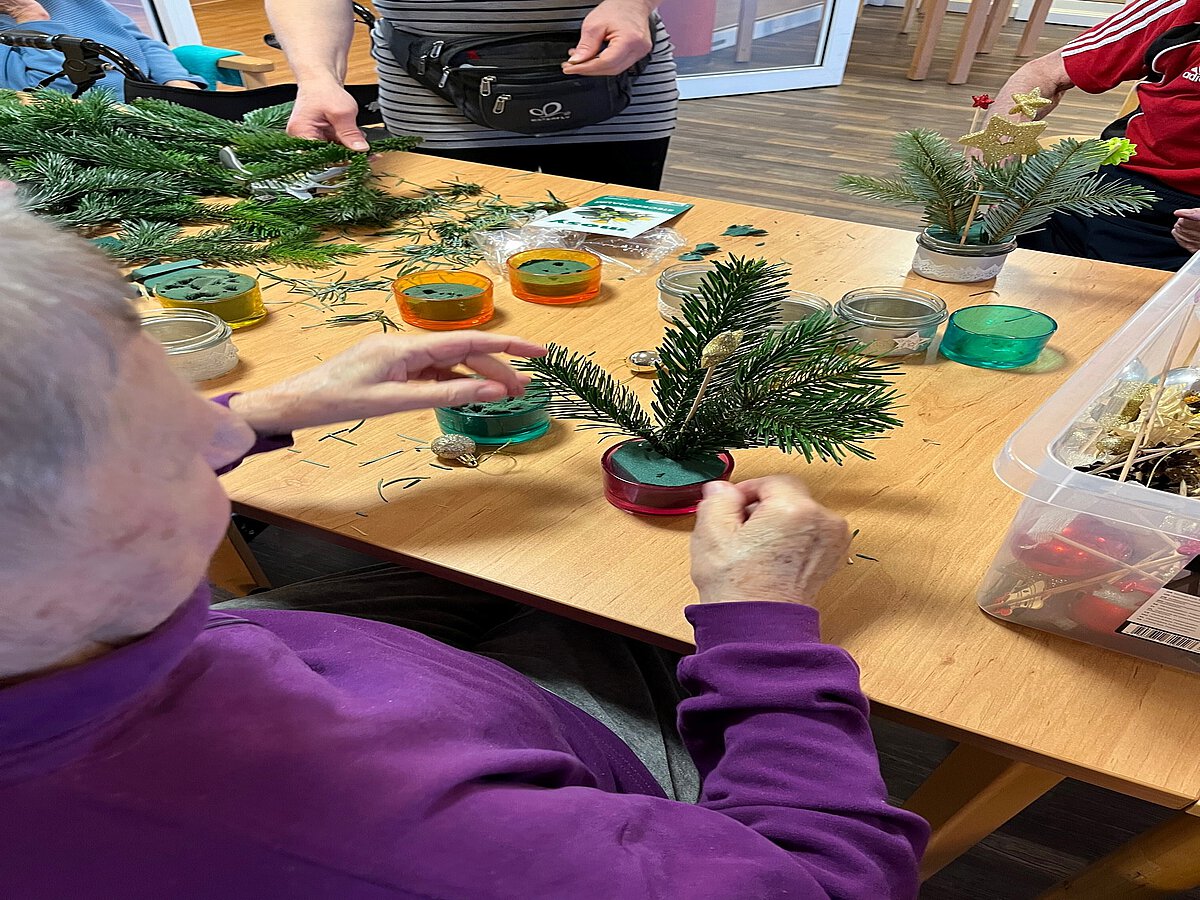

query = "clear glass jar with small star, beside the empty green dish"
[[834, 287, 949, 356]]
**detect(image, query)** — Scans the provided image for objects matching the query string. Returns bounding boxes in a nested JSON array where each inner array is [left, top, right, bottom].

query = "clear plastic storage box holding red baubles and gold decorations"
[[978, 257, 1200, 671]]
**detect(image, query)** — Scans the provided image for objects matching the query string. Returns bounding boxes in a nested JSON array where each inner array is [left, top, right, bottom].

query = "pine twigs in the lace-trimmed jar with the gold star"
[[838, 128, 1157, 244]]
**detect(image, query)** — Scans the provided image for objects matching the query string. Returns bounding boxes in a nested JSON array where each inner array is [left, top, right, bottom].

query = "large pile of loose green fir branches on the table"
[[0, 90, 446, 268]]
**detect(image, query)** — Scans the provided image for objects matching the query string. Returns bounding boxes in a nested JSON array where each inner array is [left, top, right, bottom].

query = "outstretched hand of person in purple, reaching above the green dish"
[[229, 331, 546, 434]]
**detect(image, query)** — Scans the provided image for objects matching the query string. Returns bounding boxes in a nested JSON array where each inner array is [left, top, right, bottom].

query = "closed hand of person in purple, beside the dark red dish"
[[691, 476, 850, 604]]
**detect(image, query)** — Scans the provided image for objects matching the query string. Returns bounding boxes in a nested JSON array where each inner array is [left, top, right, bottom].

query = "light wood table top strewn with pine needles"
[[204, 155, 1200, 808]]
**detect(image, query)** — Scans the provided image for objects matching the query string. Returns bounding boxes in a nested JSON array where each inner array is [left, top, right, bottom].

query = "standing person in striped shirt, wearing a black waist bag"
[[266, 0, 678, 188]]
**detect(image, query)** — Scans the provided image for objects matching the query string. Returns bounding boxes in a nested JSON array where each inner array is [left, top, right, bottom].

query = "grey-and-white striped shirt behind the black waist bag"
[[371, 0, 679, 150]]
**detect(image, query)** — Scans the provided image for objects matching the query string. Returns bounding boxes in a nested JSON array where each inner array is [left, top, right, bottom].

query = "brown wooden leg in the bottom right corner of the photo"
[[1040, 806, 1200, 900]]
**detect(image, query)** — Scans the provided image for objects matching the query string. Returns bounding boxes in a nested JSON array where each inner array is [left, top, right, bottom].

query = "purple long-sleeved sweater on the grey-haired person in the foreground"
[[0, 448, 928, 900]]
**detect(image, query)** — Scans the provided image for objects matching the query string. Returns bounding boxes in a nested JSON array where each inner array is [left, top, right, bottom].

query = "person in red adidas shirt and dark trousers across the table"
[[995, 0, 1200, 271]]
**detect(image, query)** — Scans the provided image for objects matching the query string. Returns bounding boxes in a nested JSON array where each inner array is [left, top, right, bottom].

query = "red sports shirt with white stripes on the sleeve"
[[1062, 0, 1200, 196]]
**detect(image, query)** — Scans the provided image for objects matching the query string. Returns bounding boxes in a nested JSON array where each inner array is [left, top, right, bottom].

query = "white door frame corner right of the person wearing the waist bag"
[[679, 0, 859, 100]]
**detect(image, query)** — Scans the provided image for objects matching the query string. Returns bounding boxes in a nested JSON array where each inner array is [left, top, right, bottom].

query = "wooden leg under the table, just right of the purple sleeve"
[[904, 744, 1062, 880]]
